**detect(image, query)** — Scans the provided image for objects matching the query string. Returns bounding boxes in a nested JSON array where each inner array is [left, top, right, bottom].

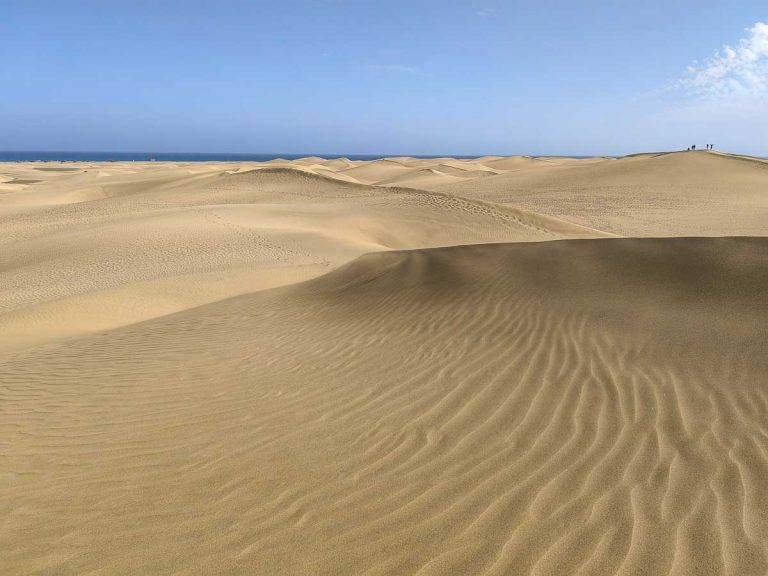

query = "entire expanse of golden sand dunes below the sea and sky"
[[0, 153, 768, 575]]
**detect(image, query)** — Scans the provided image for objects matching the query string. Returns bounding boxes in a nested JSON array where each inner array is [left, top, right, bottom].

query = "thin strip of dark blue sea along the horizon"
[[0, 150, 478, 162]]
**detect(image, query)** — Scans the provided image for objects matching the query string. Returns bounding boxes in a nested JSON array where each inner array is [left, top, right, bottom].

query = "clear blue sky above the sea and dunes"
[[0, 0, 768, 155]]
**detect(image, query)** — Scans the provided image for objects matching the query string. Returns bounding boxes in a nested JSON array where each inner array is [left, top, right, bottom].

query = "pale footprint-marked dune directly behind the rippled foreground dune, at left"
[[0, 167, 595, 352]]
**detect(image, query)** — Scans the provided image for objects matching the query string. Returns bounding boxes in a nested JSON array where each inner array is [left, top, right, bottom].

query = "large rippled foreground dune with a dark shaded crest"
[[0, 238, 768, 575]]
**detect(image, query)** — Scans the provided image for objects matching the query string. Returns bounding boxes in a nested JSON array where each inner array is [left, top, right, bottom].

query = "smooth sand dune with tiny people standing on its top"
[[435, 152, 768, 236]]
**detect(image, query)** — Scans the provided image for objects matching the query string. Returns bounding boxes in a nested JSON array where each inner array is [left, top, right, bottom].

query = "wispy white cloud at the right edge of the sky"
[[676, 22, 768, 99]]
